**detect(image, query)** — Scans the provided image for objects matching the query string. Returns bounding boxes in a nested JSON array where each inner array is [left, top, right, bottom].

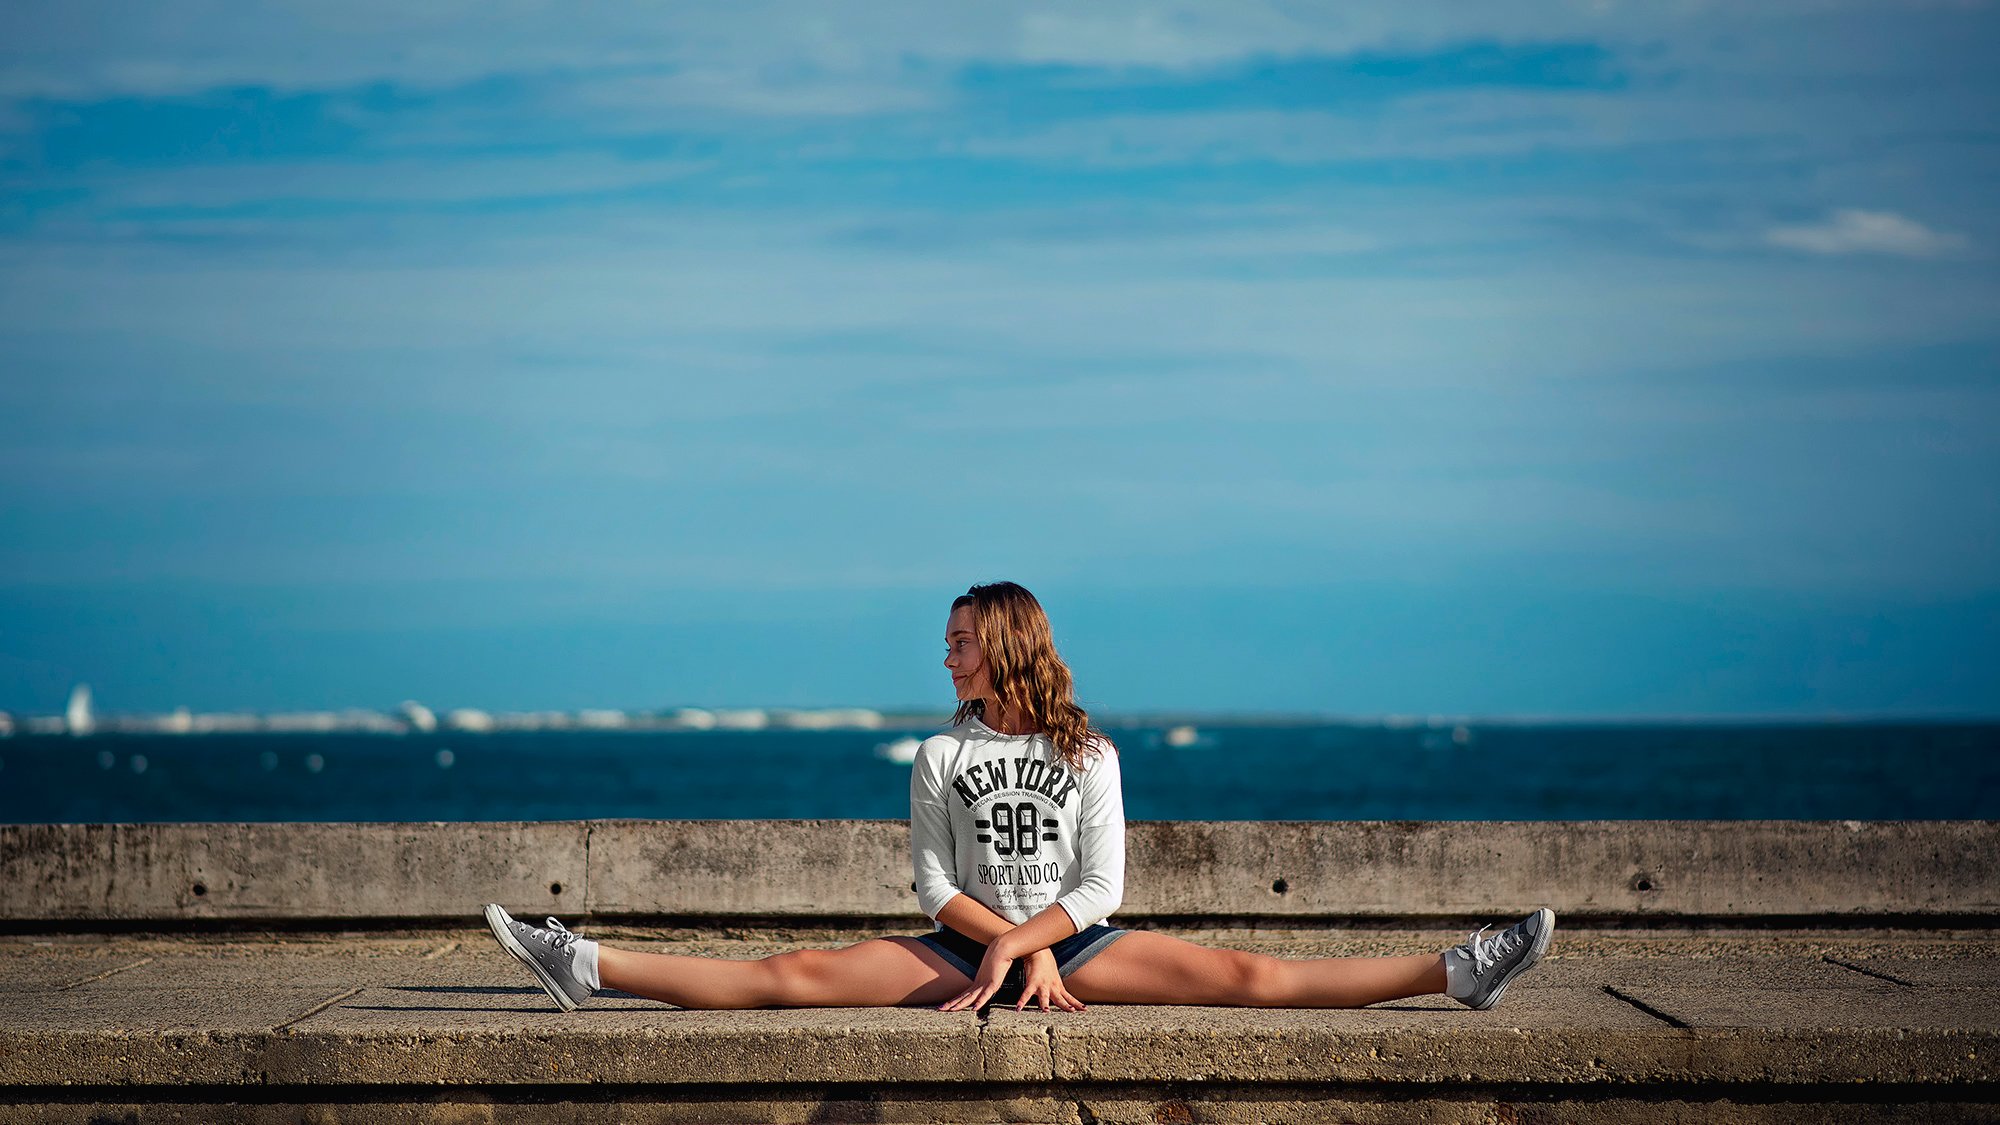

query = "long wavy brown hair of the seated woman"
[[952, 583, 1102, 773]]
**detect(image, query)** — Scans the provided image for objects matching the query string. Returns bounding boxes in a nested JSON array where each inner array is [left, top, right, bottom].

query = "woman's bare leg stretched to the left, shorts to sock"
[[598, 937, 972, 1009]]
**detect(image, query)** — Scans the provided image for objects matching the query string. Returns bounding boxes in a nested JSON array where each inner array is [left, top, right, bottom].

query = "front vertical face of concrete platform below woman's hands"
[[0, 1009, 2000, 1097]]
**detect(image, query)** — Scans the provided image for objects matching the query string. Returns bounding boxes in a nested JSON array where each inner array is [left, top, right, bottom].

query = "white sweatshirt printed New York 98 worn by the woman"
[[910, 719, 1124, 931]]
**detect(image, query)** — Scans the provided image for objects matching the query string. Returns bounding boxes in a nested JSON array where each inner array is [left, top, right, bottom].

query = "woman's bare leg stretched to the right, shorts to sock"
[[1064, 931, 1444, 1007]]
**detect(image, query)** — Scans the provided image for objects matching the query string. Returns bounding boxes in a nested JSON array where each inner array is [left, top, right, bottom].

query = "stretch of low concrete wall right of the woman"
[[1126, 821, 2000, 917]]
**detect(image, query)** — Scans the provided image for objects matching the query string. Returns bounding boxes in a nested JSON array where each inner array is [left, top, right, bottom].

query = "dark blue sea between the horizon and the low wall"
[[0, 721, 2000, 825]]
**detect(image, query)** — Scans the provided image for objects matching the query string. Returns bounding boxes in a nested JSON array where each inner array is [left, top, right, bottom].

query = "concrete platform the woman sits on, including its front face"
[[0, 927, 2000, 1123]]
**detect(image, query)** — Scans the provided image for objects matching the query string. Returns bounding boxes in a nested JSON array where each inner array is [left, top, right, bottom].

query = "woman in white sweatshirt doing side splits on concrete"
[[486, 583, 1556, 1011]]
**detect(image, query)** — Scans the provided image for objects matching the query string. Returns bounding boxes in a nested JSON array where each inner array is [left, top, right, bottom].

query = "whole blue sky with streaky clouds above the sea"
[[0, 2, 2000, 715]]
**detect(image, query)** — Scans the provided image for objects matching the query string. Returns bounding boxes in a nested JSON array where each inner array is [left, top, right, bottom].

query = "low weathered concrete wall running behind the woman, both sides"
[[0, 821, 2000, 925]]
